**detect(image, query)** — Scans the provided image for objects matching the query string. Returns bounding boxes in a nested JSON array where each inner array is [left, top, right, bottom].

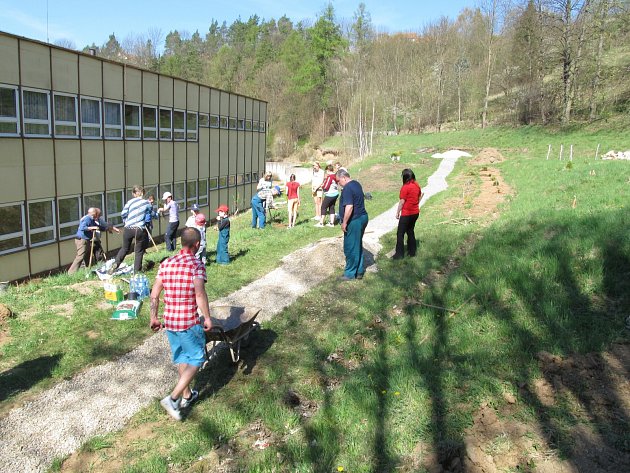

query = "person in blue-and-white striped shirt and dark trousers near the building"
[[109, 186, 151, 274]]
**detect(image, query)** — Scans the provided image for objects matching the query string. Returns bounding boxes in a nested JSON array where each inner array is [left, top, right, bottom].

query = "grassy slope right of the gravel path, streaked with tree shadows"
[[49, 124, 630, 472]]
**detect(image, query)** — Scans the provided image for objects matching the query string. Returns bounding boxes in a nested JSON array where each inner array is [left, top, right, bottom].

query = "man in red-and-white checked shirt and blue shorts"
[[150, 227, 212, 420]]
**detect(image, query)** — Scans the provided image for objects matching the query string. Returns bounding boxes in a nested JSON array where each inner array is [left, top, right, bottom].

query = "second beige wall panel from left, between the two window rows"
[[24, 140, 55, 200]]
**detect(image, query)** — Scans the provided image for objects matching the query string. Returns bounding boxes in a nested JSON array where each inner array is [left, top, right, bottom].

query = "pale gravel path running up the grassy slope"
[[0, 157, 464, 473]]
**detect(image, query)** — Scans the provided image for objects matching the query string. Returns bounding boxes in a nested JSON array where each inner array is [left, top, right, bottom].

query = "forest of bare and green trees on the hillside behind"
[[81, 0, 630, 157]]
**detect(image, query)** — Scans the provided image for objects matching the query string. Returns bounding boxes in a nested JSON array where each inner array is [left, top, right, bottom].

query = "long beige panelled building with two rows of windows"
[[0, 32, 267, 280]]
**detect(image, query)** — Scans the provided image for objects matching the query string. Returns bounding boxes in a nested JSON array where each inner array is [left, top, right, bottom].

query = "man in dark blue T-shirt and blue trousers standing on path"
[[337, 169, 368, 281]]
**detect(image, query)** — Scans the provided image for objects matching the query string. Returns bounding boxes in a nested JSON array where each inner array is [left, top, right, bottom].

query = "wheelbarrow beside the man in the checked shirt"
[[204, 305, 262, 363]]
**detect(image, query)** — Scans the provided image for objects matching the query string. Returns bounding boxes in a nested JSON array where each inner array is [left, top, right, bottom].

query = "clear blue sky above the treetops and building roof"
[[0, 0, 476, 48]]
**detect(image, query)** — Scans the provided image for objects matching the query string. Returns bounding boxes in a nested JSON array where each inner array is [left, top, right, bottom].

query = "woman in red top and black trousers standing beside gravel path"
[[393, 169, 422, 259]]
